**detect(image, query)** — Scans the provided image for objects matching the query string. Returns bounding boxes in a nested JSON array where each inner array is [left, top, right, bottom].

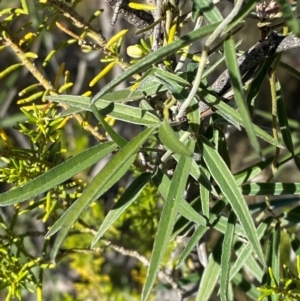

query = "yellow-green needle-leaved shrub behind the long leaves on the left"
[[0, 0, 159, 300]]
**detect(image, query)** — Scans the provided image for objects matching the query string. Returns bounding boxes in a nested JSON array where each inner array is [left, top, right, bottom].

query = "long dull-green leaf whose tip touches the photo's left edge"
[[0, 142, 117, 206]]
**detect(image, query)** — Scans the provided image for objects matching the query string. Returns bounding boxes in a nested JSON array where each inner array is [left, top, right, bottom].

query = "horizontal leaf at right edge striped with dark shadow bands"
[[241, 183, 300, 195]]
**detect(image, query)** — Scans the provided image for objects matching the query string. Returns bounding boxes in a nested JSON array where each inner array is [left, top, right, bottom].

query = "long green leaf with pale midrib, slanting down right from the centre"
[[199, 137, 264, 263]]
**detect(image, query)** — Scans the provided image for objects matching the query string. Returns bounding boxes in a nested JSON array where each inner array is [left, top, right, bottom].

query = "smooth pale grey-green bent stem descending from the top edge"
[[176, 0, 244, 119]]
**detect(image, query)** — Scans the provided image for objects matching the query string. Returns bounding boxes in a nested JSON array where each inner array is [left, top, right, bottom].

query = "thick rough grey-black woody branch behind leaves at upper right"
[[199, 31, 300, 117]]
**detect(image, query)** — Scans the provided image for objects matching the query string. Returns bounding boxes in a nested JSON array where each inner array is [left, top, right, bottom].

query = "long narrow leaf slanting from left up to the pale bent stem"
[[91, 23, 219, 104]]
